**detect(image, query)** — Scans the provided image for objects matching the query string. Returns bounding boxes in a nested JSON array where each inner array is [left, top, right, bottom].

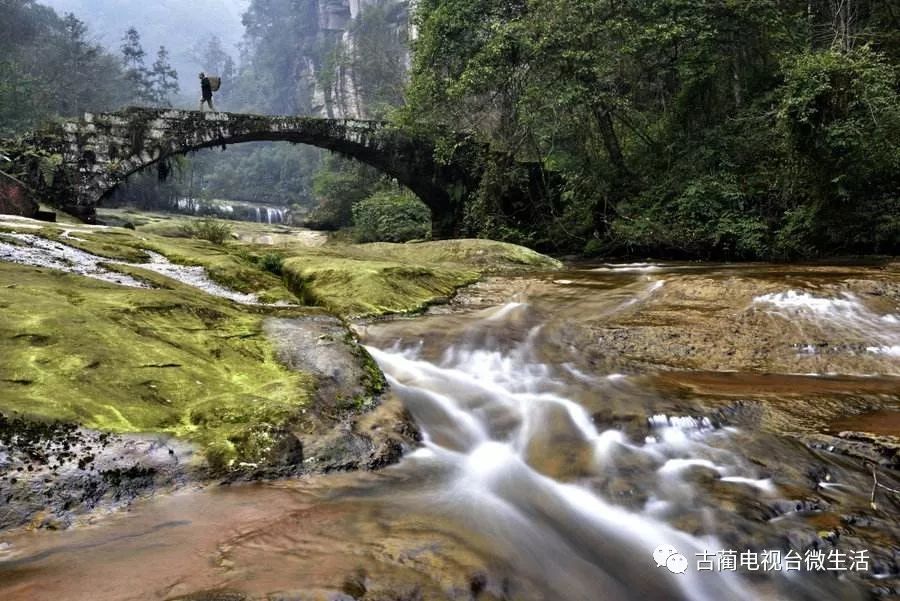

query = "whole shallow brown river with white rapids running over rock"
[[0, 264, 900, 601]]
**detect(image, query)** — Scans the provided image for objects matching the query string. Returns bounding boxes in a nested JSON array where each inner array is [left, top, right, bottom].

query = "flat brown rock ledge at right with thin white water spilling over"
[[589, 267, 900, 375]]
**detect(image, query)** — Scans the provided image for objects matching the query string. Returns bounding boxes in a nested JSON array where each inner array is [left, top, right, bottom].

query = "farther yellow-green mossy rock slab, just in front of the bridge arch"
[[41, 212, 561, 317]]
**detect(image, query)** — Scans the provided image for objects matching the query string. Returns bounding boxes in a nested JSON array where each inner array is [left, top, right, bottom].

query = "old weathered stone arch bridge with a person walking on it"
[[13, 108, 488, 236]]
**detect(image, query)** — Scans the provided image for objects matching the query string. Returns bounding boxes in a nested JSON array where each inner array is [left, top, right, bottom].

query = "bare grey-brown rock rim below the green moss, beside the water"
[[0, 316, 419, 531]]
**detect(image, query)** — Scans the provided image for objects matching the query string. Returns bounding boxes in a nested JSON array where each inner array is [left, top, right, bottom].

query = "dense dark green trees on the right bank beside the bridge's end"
[[404, 0, 900, 258]]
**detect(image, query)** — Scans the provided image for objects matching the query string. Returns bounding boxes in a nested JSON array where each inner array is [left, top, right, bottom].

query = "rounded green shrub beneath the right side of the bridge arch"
[[353, 192, 431, 242]]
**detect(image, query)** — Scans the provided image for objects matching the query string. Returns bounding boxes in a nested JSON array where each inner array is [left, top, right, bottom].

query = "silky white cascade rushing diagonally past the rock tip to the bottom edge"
[[362, 349, 753, 600]]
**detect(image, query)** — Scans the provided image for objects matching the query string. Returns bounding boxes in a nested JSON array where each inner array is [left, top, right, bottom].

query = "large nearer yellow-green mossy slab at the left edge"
[[0, 263, 313, 467]]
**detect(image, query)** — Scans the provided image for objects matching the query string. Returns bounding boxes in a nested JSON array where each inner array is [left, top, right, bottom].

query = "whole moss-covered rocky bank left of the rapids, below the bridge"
[[0, 214, 558, 516]]
